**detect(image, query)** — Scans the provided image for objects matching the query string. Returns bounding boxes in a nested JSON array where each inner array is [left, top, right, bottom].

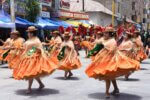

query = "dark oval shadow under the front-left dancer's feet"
[[16, 88, 59, 97]]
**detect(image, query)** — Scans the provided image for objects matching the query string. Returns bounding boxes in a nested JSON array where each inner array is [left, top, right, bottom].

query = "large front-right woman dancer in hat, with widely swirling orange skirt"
[[85, 27, 140, 98]]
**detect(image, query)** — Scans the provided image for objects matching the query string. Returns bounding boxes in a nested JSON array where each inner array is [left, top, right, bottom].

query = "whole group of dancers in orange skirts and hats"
[[0, 26, 147, 98]]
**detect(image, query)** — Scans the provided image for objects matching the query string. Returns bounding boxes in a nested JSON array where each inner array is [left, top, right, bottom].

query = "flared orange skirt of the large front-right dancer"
[[85, 49, 140, 80]]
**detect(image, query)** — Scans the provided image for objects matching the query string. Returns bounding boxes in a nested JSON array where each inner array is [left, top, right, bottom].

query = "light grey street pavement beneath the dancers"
[[0, 51, 150, 100]]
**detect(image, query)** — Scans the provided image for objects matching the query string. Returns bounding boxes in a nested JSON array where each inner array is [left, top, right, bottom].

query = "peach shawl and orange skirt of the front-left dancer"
[[13, 37, 57, 80]]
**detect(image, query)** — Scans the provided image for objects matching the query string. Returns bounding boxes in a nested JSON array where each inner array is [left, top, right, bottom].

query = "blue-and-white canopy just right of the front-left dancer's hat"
[[37, 18, 59, 29]]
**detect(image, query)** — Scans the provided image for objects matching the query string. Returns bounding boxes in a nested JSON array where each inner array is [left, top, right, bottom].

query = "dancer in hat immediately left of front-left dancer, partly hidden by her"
[[3, 31, 25, 69]]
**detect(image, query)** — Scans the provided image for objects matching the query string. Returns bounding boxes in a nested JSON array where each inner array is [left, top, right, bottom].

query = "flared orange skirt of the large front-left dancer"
[[13, 53, 57, 80]]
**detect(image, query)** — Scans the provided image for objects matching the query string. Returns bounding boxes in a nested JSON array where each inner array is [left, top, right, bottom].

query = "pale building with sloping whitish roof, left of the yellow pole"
[[70, 0, 117, 26]]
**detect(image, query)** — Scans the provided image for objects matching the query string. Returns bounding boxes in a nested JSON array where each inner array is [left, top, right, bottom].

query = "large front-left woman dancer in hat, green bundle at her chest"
[[13, 26, 57, 94]]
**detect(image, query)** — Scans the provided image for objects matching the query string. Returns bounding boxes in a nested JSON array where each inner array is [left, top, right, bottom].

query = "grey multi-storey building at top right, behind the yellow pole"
[[95, 0, 145, 23]]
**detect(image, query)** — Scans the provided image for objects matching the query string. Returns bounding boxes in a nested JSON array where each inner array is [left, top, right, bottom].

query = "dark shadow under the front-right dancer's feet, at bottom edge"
[[88, 93, 142, 100]]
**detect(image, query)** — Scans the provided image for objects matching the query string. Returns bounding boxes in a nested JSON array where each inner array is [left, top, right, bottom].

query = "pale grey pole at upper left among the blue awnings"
[[10, 0, 16, 31]]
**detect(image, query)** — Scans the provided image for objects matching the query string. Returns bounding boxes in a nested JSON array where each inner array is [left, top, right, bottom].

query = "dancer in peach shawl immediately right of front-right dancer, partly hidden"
[[118, 31, 140, 80]]
